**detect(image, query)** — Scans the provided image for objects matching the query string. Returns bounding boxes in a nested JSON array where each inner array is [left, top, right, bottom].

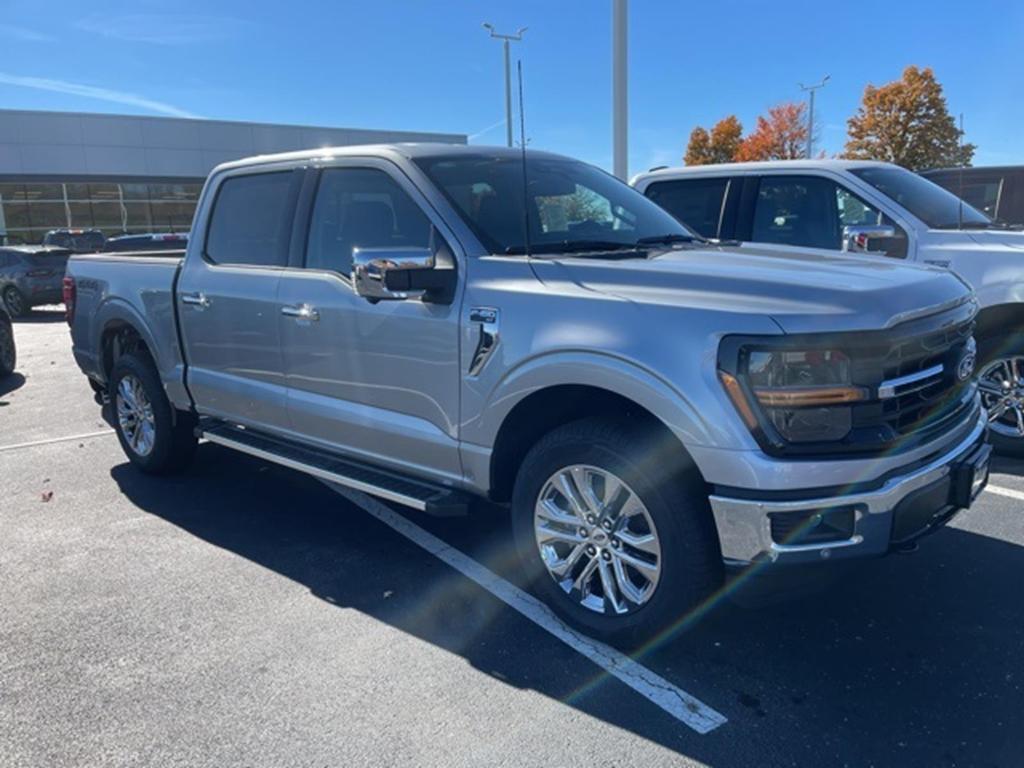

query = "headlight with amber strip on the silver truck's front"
[[719, 346, 868, 442]]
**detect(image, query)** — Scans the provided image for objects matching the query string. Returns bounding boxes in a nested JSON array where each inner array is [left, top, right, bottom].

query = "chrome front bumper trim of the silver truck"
[[710, 411, 987, 563]]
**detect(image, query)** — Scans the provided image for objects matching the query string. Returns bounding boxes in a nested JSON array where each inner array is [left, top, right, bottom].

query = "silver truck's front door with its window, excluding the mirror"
[[278, 159, 462, 481]]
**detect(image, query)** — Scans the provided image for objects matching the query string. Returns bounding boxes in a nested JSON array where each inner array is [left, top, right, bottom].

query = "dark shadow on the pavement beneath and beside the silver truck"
[[111, 444, 1024, 767]]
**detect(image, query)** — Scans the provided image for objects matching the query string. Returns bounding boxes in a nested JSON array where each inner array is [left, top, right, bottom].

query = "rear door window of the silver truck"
[[206, 171, 294, 266]]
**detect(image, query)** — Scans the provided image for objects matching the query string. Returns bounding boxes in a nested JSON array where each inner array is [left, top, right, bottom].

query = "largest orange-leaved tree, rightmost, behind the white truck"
[[843, 67, 976, 171]]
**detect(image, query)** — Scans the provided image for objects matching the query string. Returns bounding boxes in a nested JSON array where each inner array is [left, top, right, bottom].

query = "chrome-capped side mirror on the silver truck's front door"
[[352, 248, 455, 303]]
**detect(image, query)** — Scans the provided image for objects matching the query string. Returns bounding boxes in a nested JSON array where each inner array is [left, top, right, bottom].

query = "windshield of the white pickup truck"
[[851, 167, 992, 229]]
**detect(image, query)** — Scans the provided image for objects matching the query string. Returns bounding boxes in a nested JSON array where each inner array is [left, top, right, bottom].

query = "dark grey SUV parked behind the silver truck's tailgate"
[[0, 246, 71, 317]]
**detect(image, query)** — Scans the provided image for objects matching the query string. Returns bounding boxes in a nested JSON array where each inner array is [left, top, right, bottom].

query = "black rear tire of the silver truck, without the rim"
[[110, 352, 198, 474]]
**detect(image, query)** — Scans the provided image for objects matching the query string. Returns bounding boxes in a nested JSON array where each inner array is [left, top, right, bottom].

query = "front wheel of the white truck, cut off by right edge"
[[978, 336, 1024, 458]]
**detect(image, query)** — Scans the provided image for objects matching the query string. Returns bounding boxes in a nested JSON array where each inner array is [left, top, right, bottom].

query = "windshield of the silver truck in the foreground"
[[409, 155, 696, 253]]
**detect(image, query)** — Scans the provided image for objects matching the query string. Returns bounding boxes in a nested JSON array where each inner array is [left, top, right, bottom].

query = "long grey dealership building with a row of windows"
[[0, 110, 466, 244]]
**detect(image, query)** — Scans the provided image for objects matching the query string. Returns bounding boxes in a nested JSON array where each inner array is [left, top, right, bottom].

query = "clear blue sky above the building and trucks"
[[0, 0, 1024, 171]]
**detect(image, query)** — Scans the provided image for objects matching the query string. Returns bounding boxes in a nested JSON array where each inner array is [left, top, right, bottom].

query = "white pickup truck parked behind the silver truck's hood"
[[632, 160, 1024, 457]]
